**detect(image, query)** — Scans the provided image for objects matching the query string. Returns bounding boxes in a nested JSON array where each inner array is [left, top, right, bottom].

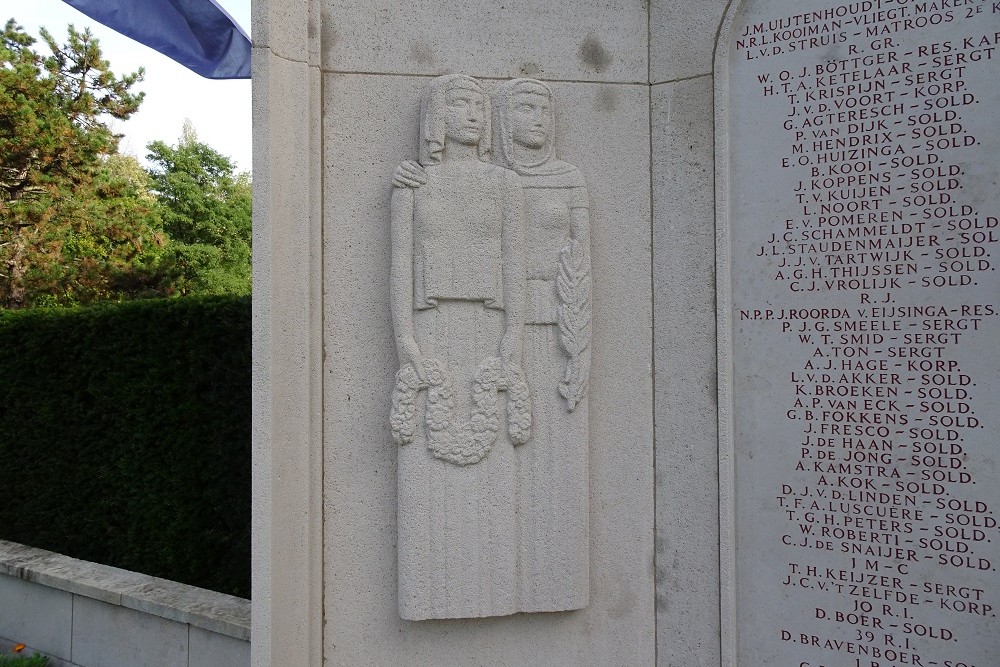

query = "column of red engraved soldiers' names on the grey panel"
[[740, 3, 997, 667]]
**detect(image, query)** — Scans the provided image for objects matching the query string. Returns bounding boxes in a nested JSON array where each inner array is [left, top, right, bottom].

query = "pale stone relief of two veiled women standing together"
[[390, 75, 591, 620]]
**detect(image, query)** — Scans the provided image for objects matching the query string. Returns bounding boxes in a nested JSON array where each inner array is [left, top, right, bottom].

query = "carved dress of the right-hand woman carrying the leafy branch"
[[516, 160, 590, 611]]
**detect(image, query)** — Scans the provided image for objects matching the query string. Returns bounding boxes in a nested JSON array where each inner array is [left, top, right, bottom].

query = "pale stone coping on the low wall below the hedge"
[[0, 540, 250, 641]]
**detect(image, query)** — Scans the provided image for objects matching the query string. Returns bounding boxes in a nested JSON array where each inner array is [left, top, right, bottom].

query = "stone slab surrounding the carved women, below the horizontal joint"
[[316, 70, 653, 664]]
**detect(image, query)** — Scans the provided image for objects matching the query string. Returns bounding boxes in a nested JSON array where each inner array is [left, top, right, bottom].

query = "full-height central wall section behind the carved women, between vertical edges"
[[321, 2, 654, 665]]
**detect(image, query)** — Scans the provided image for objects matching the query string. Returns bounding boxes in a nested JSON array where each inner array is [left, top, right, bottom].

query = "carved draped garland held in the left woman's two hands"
[[389, 357, 531, 466]]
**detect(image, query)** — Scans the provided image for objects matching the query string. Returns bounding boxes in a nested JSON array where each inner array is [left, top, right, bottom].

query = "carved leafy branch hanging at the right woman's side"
[[556, 240, 590, 412]]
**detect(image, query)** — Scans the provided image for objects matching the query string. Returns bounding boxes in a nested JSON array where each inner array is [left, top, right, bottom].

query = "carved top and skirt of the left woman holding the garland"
[[397, 163, 522, 620]]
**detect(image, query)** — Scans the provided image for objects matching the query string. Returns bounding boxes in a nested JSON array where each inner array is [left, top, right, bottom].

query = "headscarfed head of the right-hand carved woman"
[[493, 79, 555, 169]]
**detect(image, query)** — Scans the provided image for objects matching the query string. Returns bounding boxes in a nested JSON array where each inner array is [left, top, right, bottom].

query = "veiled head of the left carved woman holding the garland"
[[420, 74, 491, 167]]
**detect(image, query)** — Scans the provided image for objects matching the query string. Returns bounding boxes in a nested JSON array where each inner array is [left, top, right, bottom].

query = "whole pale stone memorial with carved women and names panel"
[[252, 0, 1000, 667]]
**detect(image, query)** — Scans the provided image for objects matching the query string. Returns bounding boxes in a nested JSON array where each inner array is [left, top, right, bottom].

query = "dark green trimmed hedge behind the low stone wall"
[[0, 297, 250, 597]]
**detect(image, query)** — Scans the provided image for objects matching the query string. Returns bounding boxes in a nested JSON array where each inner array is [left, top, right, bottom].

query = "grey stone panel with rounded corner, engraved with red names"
[[718, 0, 1000, 667]]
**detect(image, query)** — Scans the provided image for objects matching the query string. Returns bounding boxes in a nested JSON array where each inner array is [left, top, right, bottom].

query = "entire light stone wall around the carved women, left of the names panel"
[[254, 0, 727, 666]]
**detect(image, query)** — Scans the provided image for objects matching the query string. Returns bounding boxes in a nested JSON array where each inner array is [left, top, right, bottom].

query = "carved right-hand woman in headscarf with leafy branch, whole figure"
[[493, 79, 591, 611]]
